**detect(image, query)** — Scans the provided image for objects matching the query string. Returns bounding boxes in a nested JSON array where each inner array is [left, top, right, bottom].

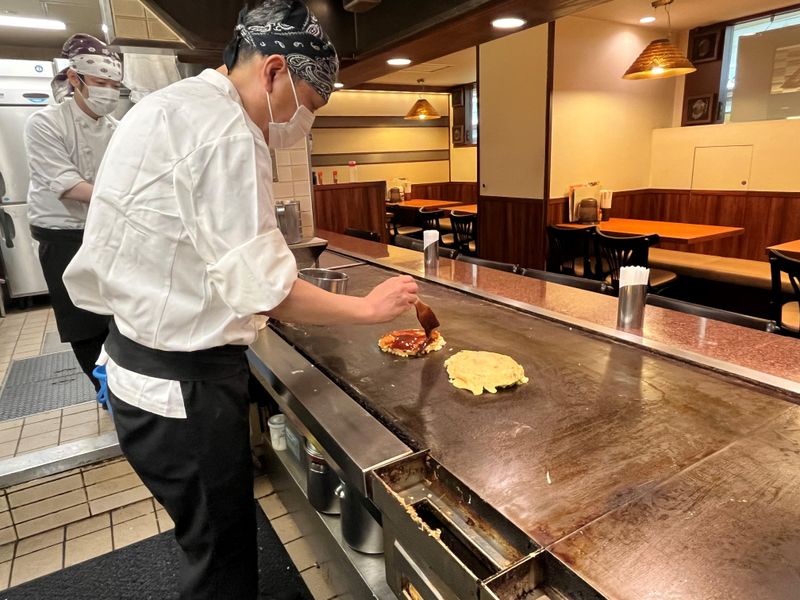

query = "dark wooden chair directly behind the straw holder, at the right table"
[[593, 231, 678, 293]]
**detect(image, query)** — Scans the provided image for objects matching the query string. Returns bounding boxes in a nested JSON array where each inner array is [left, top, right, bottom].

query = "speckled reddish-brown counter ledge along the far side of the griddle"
[[318, 231, 800, 398]]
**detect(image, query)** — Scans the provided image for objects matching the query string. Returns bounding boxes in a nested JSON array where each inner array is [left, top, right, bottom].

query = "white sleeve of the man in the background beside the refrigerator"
[[25, 113, 84, 197]]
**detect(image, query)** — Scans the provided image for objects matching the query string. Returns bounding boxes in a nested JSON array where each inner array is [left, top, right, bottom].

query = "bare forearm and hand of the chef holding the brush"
[[265, 276, 417, 325]]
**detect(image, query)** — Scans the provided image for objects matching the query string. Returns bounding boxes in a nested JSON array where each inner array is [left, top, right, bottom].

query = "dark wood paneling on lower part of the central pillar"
[[478, 196, 546, 269]]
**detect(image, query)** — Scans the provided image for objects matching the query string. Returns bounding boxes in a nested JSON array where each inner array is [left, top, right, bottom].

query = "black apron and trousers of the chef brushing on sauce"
[[105, 320, 258, 600]]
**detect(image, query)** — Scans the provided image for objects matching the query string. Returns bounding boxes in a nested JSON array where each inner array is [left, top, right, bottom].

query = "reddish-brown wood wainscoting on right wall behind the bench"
[[548, 189, 800, 261]]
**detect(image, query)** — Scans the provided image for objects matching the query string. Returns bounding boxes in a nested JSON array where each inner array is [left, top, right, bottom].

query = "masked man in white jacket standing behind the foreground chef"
[[25, 33, 122, 389]]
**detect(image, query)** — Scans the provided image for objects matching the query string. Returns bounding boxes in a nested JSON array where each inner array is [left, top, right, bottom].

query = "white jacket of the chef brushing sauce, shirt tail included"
[[64, 70, 297, 417]]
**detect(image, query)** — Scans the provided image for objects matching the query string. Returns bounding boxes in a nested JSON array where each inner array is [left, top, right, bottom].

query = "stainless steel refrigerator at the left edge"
[[0, 60, 53, 298]]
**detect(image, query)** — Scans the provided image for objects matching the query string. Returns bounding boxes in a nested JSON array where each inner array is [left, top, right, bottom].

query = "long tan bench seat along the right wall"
[[649, 248, 792, 294]]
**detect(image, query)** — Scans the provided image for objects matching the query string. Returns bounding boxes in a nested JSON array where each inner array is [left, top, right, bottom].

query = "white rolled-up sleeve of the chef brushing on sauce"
[[173, 134, 297, 316]]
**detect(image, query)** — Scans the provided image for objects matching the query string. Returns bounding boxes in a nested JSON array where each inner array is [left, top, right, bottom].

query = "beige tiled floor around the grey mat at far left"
[[0, 308, 114, 460]]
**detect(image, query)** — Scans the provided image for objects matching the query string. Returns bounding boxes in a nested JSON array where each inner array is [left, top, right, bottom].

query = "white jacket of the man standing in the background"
[[25, 98, 118, 229]]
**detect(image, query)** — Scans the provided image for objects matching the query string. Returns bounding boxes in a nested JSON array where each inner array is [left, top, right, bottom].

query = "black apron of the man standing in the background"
[[31, 226, 109, 389]]
